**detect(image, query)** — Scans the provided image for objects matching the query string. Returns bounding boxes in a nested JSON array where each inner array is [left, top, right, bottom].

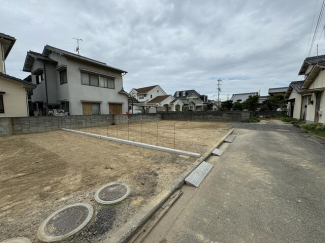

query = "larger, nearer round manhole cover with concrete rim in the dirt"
[[38, 203, 94, 242]]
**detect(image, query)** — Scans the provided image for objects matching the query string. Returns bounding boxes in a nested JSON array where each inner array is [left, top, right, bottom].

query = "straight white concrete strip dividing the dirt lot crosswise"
[[62, 128, 201, 158]]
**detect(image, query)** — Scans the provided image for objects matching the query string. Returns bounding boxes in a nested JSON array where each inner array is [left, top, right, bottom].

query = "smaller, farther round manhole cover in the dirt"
[[95, 182, 130, 204]]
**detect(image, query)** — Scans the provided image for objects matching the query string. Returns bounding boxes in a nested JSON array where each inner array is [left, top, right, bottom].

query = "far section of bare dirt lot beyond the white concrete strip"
[[77, 121, 228, 154]]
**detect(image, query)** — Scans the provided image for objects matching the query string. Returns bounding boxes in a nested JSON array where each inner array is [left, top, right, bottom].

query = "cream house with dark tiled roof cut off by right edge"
[[299, 55, 325, 124]]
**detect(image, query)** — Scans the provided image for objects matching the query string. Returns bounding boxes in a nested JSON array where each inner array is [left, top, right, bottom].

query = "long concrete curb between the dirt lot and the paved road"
[[102, 128, 235, 243]]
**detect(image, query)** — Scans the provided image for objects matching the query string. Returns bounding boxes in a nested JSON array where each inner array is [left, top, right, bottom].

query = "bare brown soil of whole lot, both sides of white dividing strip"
[[0, 121, 228, 242]]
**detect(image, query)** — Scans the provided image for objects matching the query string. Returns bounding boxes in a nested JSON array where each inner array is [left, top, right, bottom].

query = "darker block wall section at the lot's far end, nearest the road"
[[161, 111, 250, 122]]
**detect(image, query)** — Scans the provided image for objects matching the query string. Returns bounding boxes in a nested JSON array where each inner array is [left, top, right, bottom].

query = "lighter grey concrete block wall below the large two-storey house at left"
[[0, 114, 162, 136]]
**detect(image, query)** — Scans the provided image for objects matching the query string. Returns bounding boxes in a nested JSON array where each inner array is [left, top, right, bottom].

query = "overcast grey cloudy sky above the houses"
[[0, 0, 318, 100]]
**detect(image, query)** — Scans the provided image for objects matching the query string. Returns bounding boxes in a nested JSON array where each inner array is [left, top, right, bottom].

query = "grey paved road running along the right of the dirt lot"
[[144, 124, 325, 243]]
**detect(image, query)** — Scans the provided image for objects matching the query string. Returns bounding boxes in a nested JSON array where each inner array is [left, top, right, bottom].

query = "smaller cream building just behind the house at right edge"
[[285, 81, 304, 119]]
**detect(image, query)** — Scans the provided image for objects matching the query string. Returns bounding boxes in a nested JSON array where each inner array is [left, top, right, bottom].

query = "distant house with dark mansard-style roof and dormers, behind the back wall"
[[174, 89, 208, 111]]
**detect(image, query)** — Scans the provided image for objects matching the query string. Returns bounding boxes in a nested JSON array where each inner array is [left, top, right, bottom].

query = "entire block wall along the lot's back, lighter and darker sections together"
[[0, 111, 250, 136]]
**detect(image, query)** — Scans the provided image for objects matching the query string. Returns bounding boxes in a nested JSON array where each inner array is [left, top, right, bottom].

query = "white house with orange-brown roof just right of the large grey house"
[[129, 85, 167, 113]]
